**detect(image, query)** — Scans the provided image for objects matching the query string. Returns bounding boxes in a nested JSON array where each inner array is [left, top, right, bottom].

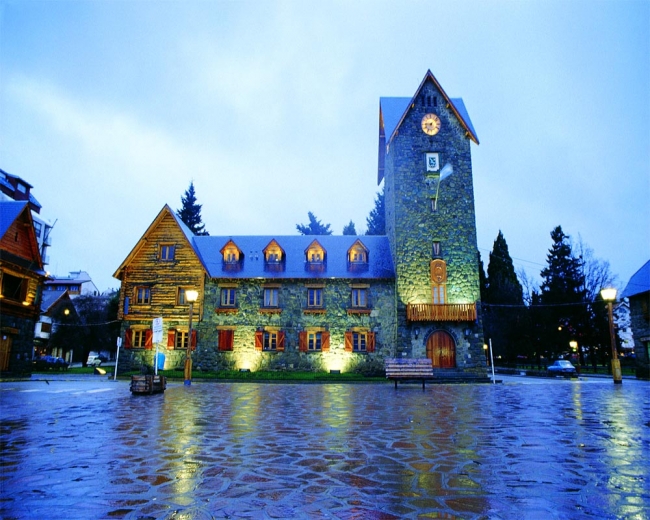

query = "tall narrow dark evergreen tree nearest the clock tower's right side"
[[483, 231, 524, 362]]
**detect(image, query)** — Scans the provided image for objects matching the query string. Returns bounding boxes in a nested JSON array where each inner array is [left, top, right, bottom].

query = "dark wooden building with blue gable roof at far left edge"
[[0, 201, 45, 375]]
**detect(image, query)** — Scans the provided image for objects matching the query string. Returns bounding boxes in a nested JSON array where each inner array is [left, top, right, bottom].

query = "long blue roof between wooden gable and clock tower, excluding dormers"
[[194, 235, 395, 279]]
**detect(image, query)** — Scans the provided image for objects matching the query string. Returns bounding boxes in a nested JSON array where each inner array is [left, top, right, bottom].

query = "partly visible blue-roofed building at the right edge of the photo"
[[621, 260, 650, 379]]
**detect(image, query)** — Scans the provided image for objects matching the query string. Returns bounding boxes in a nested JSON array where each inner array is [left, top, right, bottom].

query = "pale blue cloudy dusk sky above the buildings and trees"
[[0, 0, 650, 290]]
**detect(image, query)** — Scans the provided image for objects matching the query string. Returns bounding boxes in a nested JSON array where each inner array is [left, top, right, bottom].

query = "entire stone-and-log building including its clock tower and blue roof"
[[114, 72, 486, 374]]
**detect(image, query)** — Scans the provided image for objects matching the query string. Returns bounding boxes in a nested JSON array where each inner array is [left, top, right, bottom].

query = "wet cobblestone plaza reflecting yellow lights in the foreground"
[[0, 376, 650, 520]]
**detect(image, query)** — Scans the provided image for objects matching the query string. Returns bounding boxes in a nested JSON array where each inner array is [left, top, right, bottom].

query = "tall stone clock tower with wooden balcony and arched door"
[[378, 71, 486, 374]]
